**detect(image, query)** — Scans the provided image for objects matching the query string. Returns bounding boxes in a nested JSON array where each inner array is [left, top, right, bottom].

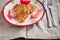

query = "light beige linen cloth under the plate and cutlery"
[[0, 0, 60, 40]]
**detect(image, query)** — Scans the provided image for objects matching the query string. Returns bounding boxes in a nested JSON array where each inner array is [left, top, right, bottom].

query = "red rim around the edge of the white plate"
[[2, 0, 46, 27]]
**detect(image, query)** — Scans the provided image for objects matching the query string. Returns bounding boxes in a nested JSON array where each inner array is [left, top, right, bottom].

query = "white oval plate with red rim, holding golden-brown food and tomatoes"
[[2, 0, 45, 26]]
